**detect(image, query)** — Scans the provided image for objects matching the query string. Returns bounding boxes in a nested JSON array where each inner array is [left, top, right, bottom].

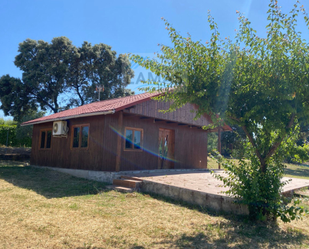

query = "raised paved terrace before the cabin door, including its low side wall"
[[122, 170, 309, 214]]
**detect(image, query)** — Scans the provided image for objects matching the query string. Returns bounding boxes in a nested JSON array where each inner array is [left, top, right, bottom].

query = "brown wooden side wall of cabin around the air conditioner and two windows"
[[31, 116, 116, 171]]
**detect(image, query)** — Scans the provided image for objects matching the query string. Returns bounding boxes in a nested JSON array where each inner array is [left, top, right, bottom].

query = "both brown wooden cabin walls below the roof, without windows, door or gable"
[[31, 112, 207, 171]]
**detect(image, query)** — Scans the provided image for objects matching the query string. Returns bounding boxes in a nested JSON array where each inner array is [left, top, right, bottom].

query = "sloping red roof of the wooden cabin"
[[21, 93, 159, 126]]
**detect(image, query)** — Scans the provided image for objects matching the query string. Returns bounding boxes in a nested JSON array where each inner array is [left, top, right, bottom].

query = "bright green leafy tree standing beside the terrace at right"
[[132, 1, 309, 221]]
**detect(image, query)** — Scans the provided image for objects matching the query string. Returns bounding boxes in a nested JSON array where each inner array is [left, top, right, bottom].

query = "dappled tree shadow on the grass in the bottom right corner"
[[156, 221, 308, 248]]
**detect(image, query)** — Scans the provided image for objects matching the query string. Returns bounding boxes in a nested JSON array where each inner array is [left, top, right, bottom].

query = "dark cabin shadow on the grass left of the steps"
[[0, 164, 107, 198]]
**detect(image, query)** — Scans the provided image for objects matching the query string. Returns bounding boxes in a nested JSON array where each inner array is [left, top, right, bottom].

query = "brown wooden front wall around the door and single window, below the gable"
[[120, 116, 207, 170]]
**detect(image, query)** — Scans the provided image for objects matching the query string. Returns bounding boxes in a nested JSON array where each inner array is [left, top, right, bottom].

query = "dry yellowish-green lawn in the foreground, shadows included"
[[0, 161, 309, 249]]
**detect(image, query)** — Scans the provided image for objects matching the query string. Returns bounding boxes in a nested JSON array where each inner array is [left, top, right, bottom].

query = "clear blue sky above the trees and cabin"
[[0, 0, 309, 117]]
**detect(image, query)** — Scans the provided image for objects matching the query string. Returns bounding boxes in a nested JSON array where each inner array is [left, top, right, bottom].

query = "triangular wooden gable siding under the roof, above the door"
[[127, 100, 211, 126]]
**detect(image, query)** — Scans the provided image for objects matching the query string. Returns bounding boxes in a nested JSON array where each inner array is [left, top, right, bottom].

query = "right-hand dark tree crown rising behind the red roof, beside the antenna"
[[67, 42, 134, 107]]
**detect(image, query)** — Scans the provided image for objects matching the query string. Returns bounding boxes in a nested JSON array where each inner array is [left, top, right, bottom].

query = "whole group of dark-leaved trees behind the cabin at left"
[[0, 37, 134, 121]]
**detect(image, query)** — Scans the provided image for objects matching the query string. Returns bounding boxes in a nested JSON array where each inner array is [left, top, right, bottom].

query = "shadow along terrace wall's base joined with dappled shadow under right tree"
[[144, 193, 309, 248]]
